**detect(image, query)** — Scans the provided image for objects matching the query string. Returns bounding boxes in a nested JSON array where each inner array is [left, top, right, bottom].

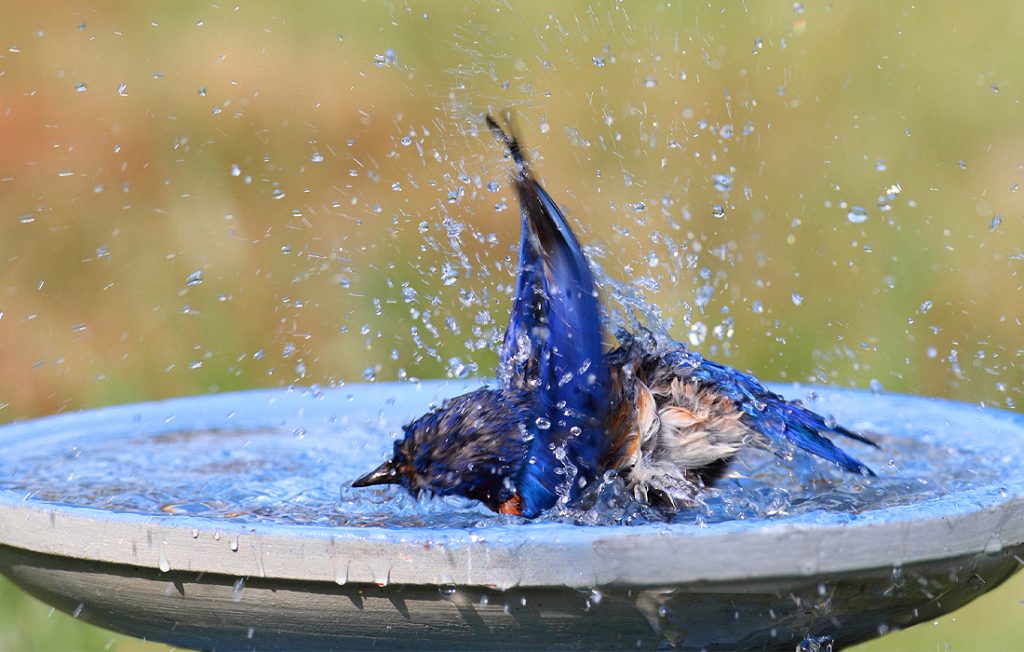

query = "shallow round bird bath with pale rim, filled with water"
[[0, 383, 1024, 650]]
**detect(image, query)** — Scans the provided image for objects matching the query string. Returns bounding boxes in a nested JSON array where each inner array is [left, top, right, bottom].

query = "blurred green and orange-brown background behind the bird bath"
[[0, 1, 1024, 651]]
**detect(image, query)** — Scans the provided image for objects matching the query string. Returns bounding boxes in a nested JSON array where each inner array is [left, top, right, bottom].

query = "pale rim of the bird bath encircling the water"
[[0, 383, 1024, 589]]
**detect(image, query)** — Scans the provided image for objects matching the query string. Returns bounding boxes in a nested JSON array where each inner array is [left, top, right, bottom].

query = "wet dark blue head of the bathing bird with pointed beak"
[[352, 388, 529, 514]]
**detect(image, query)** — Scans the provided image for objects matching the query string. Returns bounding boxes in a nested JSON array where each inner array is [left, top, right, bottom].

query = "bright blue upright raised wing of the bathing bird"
[[487, 116, 608, 516]]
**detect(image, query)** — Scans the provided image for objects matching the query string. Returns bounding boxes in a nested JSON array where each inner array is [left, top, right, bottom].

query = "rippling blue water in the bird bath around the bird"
[[0, 382, 1024, 528]]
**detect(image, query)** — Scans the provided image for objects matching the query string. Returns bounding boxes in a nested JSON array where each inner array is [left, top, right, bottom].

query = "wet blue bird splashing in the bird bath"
[[352, 115, 877, 518]]
